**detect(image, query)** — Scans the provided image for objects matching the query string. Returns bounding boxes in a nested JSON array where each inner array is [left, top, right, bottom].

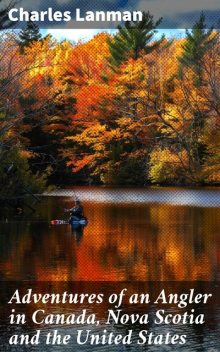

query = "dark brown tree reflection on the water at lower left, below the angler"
[[1, 223, 76, 281]]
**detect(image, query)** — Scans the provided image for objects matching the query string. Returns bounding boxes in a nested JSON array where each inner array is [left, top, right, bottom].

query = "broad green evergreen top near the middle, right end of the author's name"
[[108, 12, 164, 69]]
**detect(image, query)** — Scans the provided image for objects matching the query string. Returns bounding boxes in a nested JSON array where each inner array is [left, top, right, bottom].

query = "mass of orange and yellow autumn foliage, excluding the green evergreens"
[[0, 29, 220, 187]]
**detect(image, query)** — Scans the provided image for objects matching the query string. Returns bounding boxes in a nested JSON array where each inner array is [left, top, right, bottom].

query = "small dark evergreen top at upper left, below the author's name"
[[18, 21, 41, 54]]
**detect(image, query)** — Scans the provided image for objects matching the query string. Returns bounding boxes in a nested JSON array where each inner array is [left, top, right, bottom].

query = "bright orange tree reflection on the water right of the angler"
[[78, 205, 218, 280]]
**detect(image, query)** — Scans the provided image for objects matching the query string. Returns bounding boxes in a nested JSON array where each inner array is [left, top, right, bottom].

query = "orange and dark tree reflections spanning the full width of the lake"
[[0, 199, 220, 281]]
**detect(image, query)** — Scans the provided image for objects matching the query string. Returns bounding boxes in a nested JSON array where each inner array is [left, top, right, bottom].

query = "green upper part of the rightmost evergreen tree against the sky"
[[179, 13, 218, 85]]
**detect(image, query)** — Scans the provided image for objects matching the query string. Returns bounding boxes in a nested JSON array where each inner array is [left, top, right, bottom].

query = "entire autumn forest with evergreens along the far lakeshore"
[[0, 13, 220, 204]]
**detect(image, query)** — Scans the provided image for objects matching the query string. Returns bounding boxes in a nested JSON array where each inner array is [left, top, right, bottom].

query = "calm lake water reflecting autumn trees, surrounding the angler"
[[0, 188, 220, 352]]
